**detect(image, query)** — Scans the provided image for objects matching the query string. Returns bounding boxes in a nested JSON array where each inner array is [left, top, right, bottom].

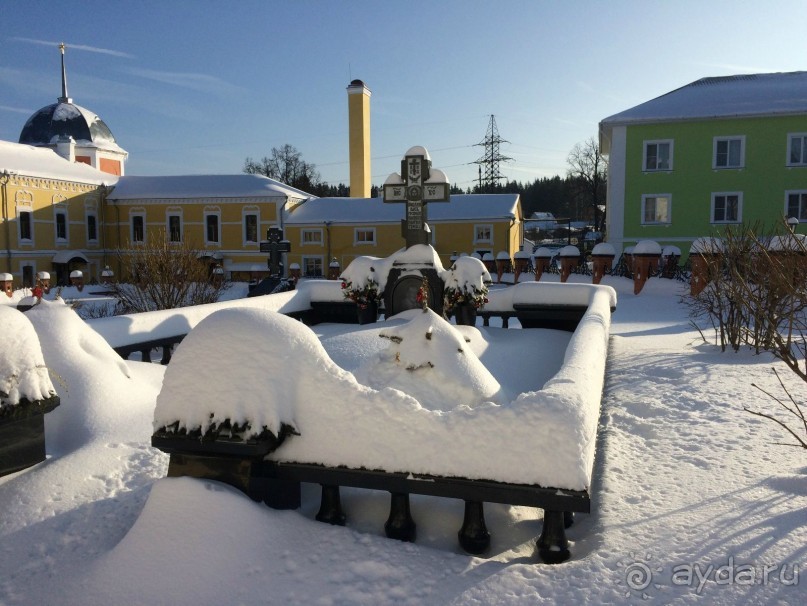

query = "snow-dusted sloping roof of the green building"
[[600, 72, 807, 145]]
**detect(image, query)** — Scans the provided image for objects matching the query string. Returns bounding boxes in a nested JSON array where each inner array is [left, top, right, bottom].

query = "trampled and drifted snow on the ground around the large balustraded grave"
[[0, 276, 807, 606]]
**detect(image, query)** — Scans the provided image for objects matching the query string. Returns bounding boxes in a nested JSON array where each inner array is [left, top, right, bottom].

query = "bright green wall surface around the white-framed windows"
[[625, 116, 807, 246]]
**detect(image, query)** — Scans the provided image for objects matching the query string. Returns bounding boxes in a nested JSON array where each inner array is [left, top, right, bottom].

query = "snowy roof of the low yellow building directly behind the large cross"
[[286, 194, 519, 225]]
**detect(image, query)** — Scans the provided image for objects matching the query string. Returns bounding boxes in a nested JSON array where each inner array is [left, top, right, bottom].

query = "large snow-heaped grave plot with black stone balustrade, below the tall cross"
[[148, 247, 616, 562]]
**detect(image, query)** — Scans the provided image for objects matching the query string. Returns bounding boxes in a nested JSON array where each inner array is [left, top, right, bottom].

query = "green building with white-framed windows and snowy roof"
[[600, 72, 807, 256]]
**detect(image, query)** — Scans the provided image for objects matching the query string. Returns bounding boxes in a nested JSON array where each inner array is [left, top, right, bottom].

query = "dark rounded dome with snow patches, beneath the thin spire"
[[19, 102, 118, 148]]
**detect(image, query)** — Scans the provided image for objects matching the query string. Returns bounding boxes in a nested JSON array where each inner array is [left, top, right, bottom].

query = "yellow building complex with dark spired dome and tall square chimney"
[[0, 47, 523, 287]]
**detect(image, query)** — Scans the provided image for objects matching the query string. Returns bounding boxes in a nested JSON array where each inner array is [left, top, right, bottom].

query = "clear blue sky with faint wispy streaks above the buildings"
[[0, 0, 807, 188]]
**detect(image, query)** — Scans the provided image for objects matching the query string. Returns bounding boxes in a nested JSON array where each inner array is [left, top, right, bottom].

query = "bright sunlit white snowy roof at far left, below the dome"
[[0, 141, 115, 185]]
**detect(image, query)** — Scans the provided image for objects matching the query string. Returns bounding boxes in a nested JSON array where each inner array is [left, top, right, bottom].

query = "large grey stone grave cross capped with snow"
[[384, 146, 449, 248]]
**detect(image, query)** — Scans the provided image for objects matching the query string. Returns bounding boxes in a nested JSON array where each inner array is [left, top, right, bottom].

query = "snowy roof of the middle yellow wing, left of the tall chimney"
[[108, 174, 318, 200]]
